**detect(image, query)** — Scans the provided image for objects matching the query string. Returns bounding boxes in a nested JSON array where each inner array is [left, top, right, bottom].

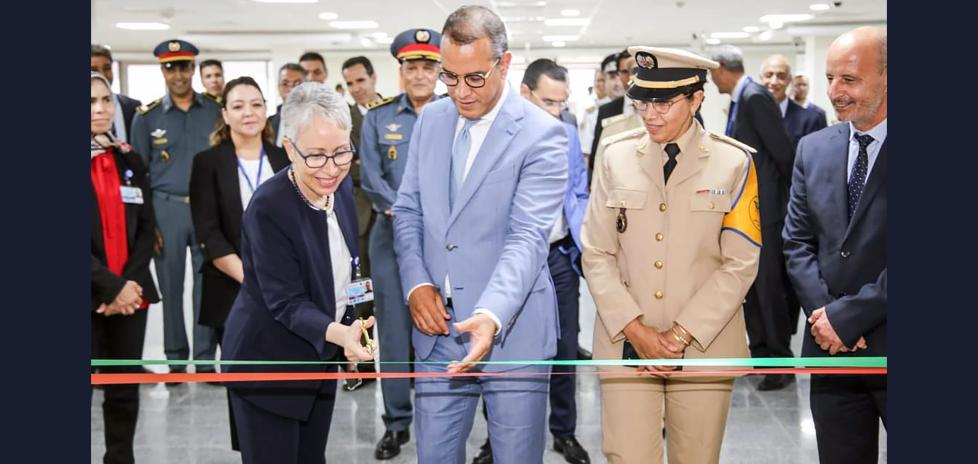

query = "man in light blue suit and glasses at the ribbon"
[[393, 6, 568, 464]]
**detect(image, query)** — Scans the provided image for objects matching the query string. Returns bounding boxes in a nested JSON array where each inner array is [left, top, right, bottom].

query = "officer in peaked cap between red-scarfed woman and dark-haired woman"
[[131, 39, 221, 372]]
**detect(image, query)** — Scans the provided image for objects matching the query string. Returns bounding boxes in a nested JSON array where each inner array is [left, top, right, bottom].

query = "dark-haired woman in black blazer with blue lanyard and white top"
[[190, 76, 289, 450]]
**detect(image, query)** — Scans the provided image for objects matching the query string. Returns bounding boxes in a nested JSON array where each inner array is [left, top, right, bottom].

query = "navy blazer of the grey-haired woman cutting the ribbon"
[[222, 169, 358, 420]]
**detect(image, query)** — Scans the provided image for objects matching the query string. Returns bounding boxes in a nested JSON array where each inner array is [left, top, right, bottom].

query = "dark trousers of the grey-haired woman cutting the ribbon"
[[228, 380, 336, 464]]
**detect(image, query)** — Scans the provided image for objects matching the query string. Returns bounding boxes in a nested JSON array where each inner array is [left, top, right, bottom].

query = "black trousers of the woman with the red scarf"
[[91, 309, 146, 464]]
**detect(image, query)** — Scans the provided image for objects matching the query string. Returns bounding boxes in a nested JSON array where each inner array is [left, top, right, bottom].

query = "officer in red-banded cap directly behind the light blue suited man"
[[360, 29, 441, 459]]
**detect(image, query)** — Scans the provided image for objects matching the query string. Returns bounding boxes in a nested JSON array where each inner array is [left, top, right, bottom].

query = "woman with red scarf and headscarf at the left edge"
[[89, 72, 160, 463]]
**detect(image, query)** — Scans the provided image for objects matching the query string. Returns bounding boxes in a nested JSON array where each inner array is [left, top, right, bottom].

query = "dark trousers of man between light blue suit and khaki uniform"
[[547, 236, 581, 437]]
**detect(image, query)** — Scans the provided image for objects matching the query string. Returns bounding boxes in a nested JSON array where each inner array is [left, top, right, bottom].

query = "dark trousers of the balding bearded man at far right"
[[811, 375, 886, 464]]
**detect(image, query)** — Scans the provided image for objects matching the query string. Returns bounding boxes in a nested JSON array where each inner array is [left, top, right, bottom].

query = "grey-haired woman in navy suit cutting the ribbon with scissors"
[[222, 82, 377, 464]]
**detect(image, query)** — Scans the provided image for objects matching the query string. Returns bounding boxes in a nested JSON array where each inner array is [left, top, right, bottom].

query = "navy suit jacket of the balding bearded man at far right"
[[782, 123, 887, 356]]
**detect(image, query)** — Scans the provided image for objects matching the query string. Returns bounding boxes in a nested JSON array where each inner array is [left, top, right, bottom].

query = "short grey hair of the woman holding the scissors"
[[282, 82, 353, 140]]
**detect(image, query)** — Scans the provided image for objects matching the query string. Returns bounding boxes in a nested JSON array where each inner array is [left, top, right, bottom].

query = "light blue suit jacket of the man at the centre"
[[394, 89, 568, 371]]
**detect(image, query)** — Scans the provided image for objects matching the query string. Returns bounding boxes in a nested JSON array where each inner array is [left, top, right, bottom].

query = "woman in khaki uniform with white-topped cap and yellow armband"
[[582, 47, 760, 464]]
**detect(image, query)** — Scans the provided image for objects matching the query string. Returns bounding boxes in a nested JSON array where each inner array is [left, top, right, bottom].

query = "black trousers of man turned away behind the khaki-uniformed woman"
[[744, 225, 798, 358]]
